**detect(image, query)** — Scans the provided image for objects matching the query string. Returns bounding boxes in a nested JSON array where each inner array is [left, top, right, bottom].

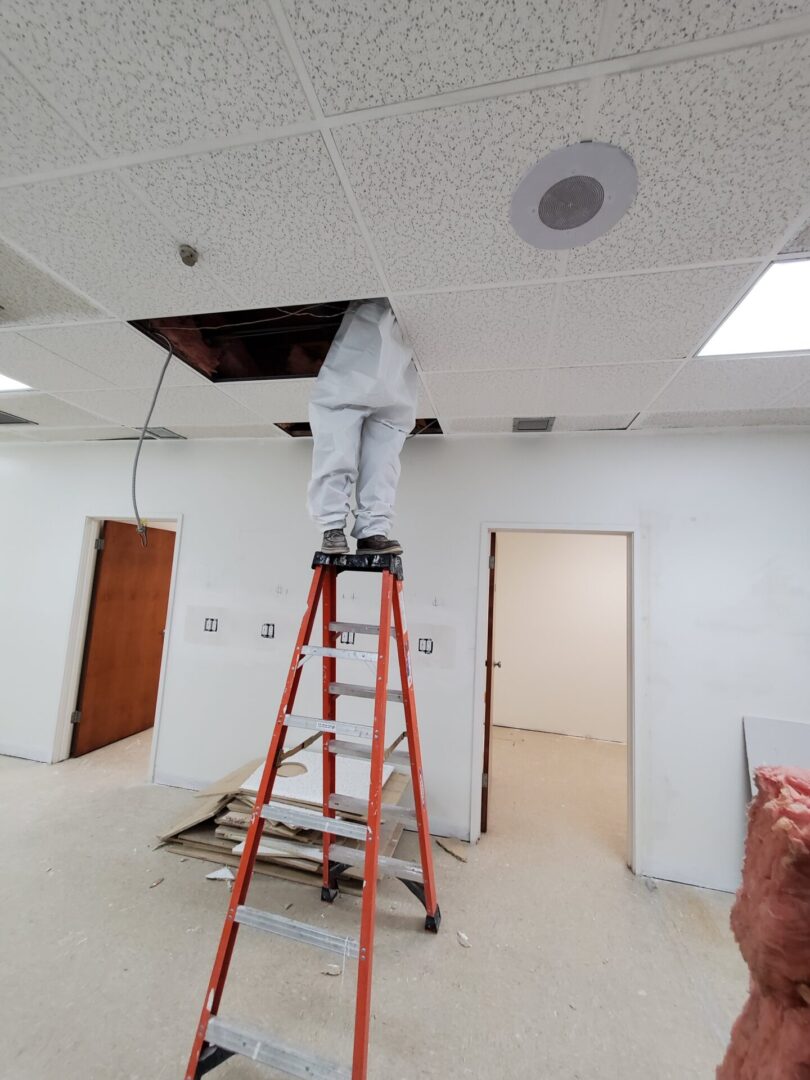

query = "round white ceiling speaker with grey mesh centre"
[[509, 143, 638, 251]]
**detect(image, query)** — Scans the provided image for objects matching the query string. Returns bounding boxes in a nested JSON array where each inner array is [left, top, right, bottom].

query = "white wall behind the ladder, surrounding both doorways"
[[0, 432, 810, 889]]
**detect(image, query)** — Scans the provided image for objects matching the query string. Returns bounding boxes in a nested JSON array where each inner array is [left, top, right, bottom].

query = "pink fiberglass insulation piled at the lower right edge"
[[717, 767, 810, 1080]]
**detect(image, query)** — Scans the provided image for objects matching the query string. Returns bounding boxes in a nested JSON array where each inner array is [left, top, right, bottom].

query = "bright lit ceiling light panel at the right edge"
[[698, 259, 810, 356]]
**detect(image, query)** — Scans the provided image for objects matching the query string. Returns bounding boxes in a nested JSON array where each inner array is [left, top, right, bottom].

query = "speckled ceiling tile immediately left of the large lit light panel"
[[548, 266, 755, 366]]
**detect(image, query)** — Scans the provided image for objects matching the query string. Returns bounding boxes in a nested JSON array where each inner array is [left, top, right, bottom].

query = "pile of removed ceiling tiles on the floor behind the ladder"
[[160, 751, 410, 890]]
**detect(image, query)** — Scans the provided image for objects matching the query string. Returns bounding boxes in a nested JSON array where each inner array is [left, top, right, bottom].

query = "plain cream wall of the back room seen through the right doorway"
[[492, 531, 627, 742]]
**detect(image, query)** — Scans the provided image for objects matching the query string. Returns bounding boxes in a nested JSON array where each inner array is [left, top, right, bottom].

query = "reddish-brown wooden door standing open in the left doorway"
[[70, 522, 175, 757]]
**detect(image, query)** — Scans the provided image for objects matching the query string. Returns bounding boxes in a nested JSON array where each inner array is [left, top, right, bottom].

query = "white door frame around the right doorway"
[[470, 522, 646, 874]]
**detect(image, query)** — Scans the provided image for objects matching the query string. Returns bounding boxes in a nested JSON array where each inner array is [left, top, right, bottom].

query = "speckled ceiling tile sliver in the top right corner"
[[610, 0, 810, 56]]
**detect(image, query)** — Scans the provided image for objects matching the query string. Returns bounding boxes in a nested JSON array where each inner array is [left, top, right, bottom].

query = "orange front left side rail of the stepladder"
[[185, 566, 325, 1080]]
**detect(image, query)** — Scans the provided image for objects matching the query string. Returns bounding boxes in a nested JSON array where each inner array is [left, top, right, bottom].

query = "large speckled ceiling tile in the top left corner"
[[0, 0, 309, 156]]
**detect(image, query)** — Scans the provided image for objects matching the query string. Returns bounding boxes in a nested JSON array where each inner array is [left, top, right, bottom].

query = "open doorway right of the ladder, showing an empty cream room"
[[481, 529, 632, 858]]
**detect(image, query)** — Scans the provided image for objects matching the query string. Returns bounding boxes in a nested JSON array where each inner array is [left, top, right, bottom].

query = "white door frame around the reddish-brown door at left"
[[51, 513, 183, 783]]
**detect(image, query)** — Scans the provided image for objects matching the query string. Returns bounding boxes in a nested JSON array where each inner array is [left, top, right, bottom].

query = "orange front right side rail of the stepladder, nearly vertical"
[[352, 571, 394, 1080]]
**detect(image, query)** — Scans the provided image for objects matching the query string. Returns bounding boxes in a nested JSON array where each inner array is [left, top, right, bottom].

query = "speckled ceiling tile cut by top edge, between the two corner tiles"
[[284, 0, 602, 113]]
